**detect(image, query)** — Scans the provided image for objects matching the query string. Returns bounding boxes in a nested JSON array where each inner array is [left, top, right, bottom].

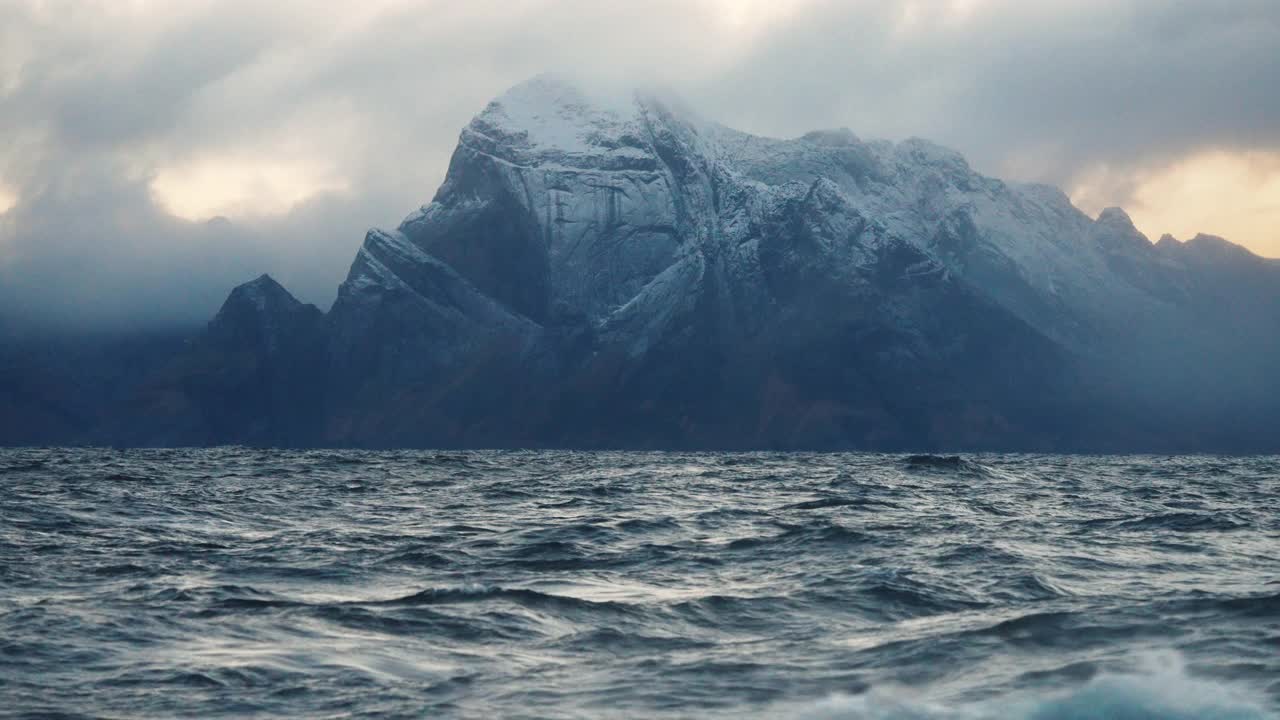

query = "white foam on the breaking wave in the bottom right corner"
[[787, 655, 1280, 720]]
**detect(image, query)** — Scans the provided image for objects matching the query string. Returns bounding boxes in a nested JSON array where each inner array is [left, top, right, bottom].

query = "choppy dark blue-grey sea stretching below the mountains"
[[0, 448, 1280, 720]]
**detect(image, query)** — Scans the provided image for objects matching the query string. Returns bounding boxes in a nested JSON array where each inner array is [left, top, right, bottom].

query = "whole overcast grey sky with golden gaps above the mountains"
[[0, 0, 1280, 327]]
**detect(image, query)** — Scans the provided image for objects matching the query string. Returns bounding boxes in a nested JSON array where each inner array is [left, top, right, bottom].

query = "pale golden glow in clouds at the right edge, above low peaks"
[[1071, 150, 1280, 258]]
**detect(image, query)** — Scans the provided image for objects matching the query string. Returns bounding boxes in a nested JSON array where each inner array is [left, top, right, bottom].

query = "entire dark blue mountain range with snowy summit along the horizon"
[[0, 77, 1280, 452]]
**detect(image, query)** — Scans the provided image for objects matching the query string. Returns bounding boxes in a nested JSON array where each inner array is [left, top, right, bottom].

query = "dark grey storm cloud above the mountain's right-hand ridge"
[[708, 1, 1280, 183]]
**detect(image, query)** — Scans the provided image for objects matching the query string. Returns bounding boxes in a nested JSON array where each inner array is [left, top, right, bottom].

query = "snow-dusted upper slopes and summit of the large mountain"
[[353, 76, 1208, 347]]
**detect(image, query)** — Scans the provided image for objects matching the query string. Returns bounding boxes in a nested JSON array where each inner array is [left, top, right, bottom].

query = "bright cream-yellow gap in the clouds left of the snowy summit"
[[151, 158, 347, 220]]
